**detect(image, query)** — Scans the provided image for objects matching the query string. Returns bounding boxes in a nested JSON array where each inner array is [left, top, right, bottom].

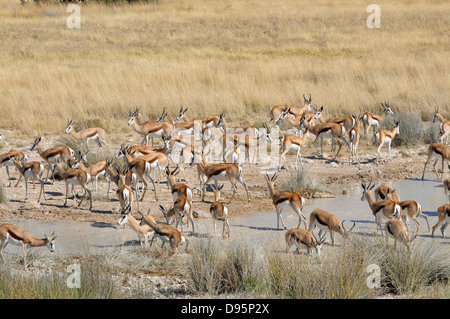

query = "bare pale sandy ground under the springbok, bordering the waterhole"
[[0, 137, 432, 224]]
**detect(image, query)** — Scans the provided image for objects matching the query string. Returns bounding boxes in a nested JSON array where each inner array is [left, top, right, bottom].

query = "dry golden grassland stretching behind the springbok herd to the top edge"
[[0, 0, 450, 137]]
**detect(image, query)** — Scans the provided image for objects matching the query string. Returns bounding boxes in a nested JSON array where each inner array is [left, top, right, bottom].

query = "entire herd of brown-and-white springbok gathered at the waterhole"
[[0, 95, 450, 268]]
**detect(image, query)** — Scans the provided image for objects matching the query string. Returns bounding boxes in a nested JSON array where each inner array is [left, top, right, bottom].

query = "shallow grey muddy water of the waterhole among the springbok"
[[1, 174, 448, 254]]
